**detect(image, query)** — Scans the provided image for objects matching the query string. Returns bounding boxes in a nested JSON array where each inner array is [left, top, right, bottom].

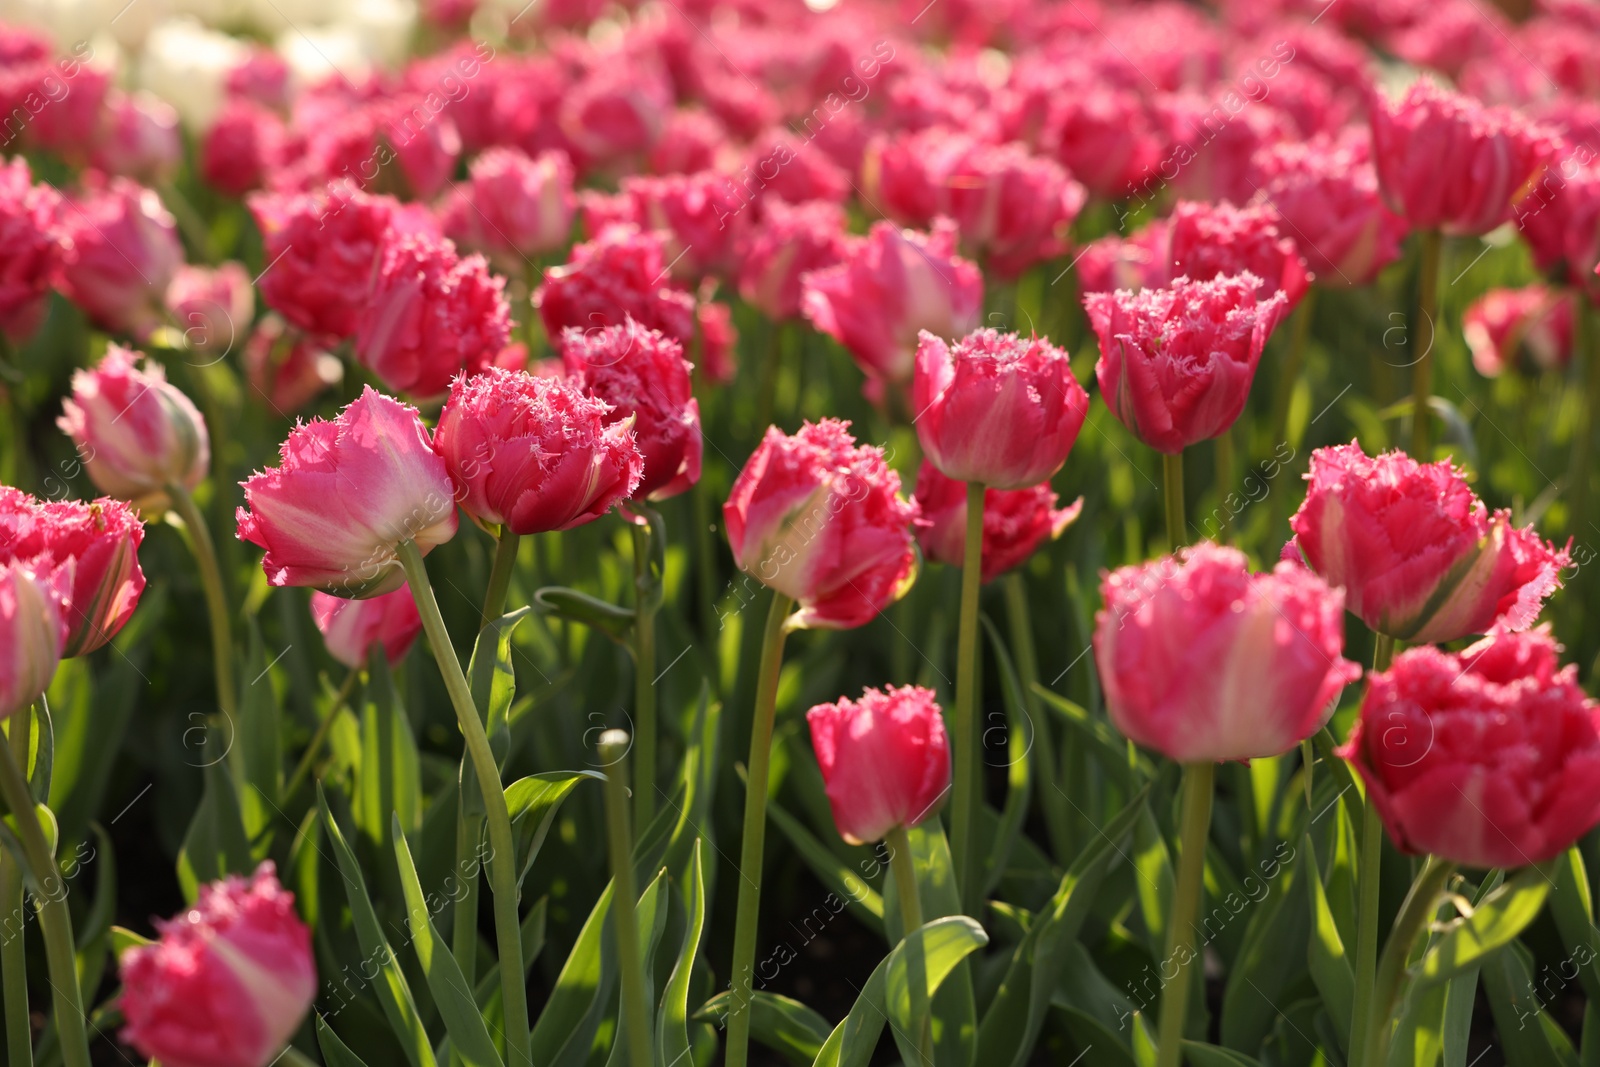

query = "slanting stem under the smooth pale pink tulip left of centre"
[[395, 539, 533, 1067]]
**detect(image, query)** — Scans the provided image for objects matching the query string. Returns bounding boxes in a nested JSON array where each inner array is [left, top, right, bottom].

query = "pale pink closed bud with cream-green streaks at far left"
[[56, 344, 211, 512]]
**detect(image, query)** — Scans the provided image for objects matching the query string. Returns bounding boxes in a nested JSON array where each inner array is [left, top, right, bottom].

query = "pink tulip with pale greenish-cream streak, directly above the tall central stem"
[[722, 419, 917, 629]]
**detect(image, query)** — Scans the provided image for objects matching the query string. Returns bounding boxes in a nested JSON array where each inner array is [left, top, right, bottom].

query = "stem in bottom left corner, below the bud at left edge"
[[0, 710, 90, 1067]]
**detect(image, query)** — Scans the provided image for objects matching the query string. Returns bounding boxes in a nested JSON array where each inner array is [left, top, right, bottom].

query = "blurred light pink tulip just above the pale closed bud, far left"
[[61, 171, 184, 339]]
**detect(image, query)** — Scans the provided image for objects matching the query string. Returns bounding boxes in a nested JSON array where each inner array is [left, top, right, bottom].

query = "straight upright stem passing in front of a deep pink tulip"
[[950, 482, 984, 915]]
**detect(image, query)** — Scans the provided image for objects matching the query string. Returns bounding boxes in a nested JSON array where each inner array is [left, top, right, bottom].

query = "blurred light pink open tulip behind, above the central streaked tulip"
[[802, 219, 984, 382]]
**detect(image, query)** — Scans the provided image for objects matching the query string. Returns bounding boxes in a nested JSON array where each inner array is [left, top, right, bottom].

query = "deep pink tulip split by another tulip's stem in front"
[[912, 461, 1083, 582]]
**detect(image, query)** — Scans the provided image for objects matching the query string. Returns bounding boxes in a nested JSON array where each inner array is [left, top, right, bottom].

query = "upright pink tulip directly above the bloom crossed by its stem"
[[912, 330, 1090, 490]]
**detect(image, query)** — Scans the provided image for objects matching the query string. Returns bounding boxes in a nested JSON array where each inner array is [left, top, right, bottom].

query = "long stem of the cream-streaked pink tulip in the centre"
[[723, 590, 794, 1067]]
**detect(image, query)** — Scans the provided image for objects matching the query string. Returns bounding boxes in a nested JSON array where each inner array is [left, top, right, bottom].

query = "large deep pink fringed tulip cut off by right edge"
[[1339, 627, 1600, 867]]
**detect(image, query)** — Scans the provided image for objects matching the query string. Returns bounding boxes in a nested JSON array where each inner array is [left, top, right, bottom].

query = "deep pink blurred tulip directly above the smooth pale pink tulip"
[[355, 234, 510, 397]]
